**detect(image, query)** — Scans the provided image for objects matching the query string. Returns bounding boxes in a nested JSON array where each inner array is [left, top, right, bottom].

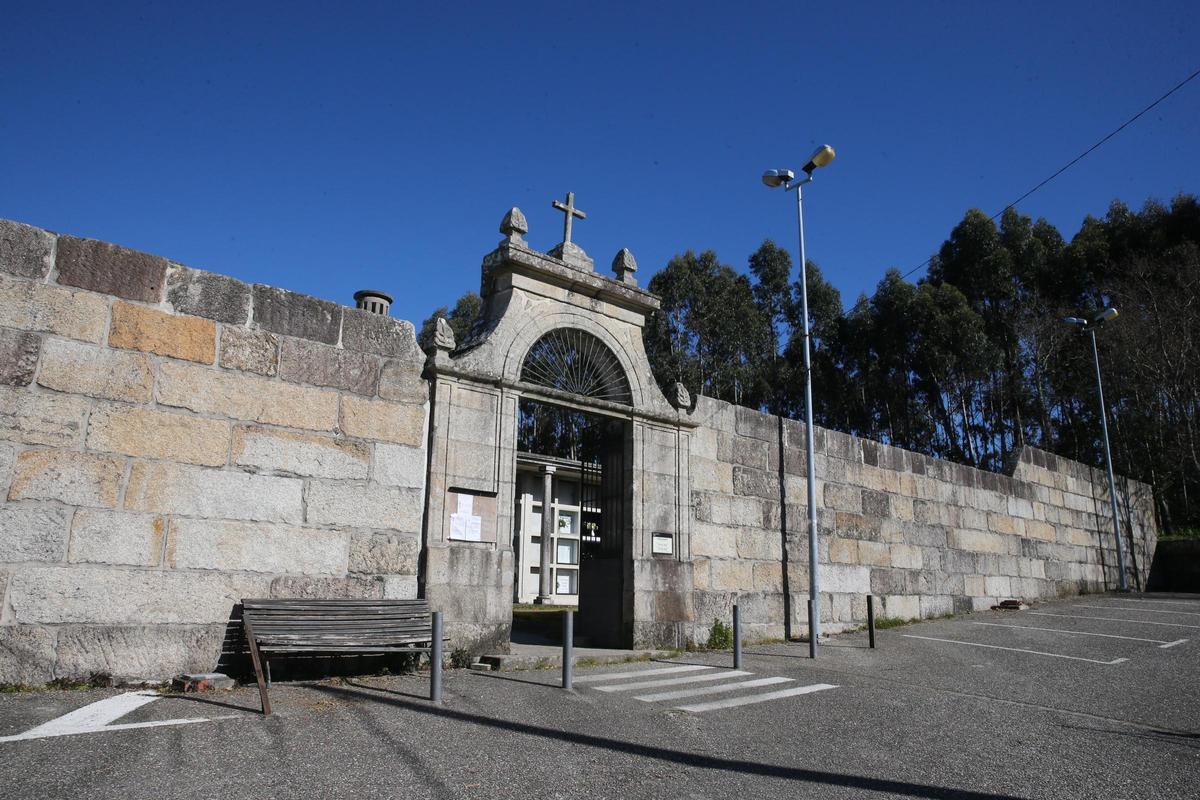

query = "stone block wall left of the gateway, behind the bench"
[[0, 221, 428, 684]]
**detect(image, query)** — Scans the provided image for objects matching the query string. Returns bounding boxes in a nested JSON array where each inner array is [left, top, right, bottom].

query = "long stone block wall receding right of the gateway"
[[691, 397, 1157, 639]]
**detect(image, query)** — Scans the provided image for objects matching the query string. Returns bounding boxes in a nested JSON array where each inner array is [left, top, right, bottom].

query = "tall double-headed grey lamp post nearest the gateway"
[[762, 144, 836, 643]]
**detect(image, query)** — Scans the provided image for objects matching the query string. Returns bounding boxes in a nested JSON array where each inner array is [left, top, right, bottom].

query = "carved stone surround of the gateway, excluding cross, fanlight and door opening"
[[420, 212, 695, 650]]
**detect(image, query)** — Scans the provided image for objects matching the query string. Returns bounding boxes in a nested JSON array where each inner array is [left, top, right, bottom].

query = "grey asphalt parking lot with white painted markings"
[[0, 595, 1200, 800]]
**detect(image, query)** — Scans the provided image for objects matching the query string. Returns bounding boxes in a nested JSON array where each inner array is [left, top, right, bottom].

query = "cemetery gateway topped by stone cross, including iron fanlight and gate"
[[419, 196, 695, 652]]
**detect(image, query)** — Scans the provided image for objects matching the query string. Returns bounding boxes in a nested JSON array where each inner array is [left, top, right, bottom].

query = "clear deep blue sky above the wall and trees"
[[0, 0, 1200, 323]]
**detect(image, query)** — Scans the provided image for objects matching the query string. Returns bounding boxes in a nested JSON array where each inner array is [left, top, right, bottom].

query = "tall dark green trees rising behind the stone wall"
[[425, 194, 1200, 531]]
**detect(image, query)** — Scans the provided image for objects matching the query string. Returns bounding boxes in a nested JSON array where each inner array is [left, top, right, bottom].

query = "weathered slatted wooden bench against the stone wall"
[[241, 600, 443, 716]]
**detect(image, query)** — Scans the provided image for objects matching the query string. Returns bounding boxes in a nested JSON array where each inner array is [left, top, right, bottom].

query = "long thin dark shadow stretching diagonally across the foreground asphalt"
[[312, 686, 1018, 800]]
